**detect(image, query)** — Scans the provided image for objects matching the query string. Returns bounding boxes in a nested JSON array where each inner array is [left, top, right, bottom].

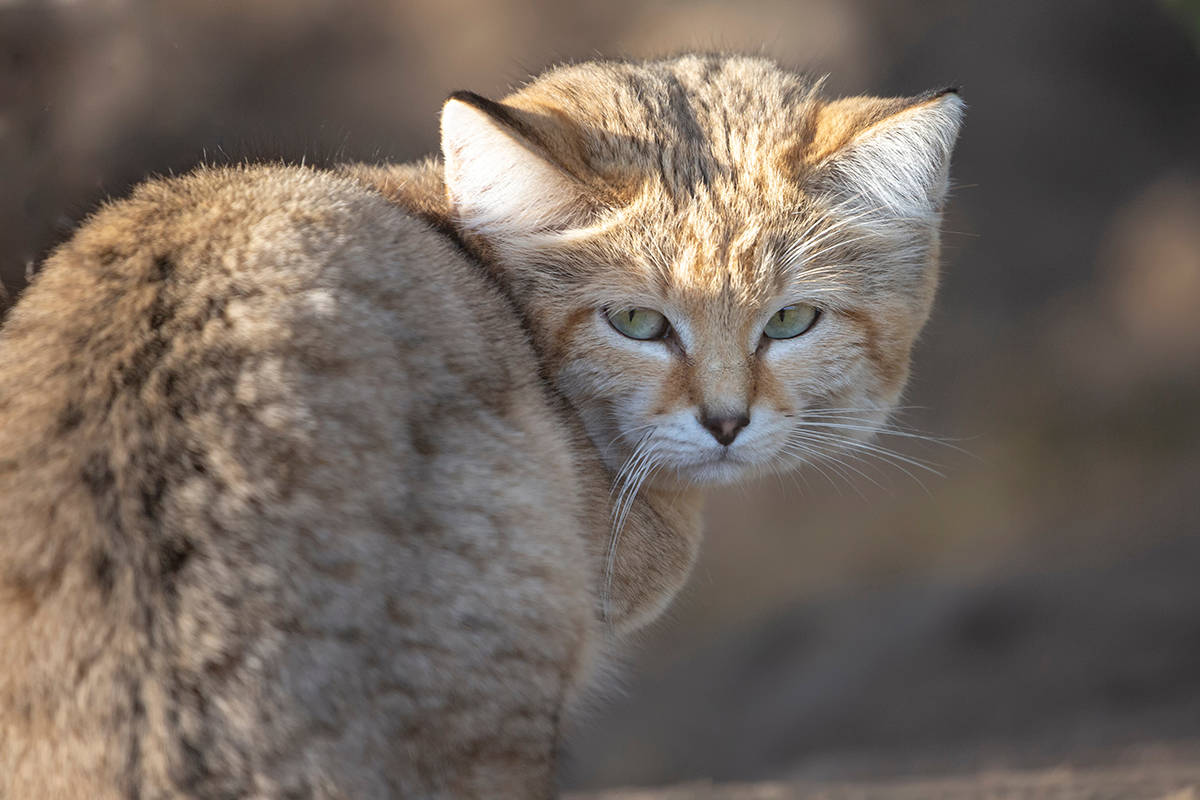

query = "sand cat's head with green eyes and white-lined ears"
[[442, 56, 964, 483]]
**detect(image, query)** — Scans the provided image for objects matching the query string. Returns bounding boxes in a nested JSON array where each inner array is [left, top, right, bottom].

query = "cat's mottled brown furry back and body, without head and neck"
[[0, 167, 592, 798]]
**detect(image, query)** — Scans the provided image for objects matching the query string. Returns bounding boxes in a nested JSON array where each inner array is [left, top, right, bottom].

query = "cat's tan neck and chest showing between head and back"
[[341, 158, 703, 633]]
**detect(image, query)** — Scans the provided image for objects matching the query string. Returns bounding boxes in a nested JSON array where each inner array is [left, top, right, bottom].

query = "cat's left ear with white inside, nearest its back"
[[442, 91, 588, 240]]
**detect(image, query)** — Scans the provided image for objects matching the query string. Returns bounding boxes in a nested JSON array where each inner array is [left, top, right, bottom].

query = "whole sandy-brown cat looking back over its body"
[[0, 56, 962, 800]]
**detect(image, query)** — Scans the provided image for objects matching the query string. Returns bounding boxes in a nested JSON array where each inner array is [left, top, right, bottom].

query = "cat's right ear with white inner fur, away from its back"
[[818, 89, 965, 219]]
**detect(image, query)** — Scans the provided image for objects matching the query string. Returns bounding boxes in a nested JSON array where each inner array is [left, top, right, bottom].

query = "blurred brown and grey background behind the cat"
[[0, 0, 1200, 788]]
